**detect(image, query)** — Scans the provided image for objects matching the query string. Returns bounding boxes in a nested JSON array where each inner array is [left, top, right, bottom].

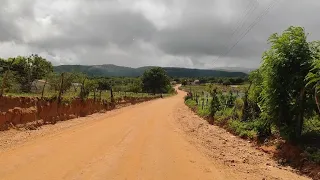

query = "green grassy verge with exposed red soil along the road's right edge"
[[185, 98, 320, 179]]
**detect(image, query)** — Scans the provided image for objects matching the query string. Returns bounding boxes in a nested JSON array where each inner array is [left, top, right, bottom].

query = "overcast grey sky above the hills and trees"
[[0, 0, 320, 69]]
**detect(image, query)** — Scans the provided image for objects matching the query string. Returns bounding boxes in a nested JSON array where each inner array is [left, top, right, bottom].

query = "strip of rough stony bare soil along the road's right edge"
[[175, 102, 308, 180]]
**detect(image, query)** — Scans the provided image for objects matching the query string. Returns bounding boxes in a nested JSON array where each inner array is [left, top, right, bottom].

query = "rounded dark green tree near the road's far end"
[[142, 67, 171, 94]]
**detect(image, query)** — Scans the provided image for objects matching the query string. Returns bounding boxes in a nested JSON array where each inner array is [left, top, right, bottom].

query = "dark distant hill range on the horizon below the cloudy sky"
[[54, 64, 247, 77]]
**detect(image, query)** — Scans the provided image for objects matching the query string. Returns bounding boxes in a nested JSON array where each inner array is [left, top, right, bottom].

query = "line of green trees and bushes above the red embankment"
[[0, 55, 174, 98]]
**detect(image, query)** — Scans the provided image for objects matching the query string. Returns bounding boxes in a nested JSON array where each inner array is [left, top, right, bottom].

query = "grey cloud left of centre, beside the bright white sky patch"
[[30, 12, 155, 49]]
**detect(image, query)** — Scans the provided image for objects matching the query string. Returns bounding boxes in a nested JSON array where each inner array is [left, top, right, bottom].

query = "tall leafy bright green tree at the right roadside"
[[259, 27, 312, 139]]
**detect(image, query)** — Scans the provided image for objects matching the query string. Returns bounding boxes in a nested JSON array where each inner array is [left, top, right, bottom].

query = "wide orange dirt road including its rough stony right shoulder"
[[0, 91, 306, 180]]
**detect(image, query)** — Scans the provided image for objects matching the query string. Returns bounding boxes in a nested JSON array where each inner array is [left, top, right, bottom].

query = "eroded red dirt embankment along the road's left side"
[[0, 96, 158, 130]]
